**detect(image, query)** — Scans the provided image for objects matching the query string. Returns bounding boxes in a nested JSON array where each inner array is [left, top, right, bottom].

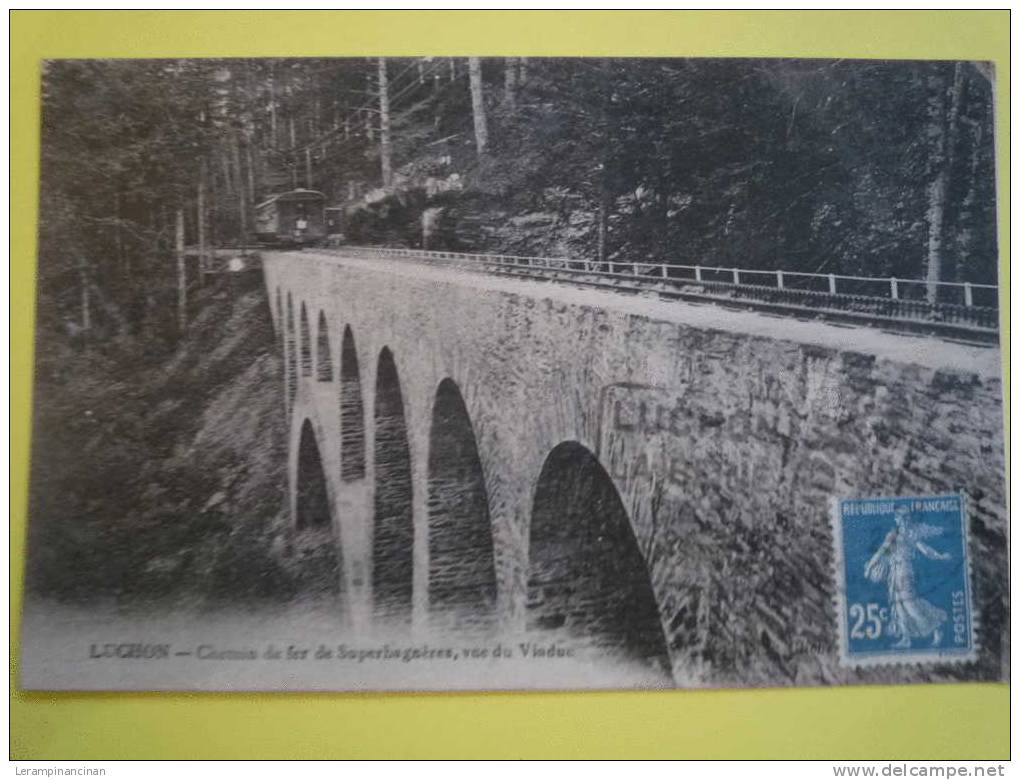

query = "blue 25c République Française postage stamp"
[[832, 493, 977, 667]]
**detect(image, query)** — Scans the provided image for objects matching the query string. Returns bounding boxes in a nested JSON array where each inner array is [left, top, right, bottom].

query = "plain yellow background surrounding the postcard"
[[10, 11, 1010, 759]]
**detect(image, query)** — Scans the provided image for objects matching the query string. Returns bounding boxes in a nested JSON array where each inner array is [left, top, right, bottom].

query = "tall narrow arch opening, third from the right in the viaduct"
[[372, 347, 414, 622]]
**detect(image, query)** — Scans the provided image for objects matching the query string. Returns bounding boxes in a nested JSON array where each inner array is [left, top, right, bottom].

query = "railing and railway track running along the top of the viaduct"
[[320, 247, 999, 334]]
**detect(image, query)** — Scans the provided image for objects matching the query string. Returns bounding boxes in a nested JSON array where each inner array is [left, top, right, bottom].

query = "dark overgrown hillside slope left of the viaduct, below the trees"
[[27, 274, 312, 605]]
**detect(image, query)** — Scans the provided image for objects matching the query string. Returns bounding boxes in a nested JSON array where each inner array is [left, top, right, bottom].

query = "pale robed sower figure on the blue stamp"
[[864, 506, 952, 648]]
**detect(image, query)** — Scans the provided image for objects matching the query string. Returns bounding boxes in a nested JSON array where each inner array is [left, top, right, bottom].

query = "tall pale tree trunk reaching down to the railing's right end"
[[925, 62, 963, 303]]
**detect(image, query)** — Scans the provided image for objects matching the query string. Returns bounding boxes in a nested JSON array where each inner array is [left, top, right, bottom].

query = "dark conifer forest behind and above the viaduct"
[[38, 57, 998, 346]]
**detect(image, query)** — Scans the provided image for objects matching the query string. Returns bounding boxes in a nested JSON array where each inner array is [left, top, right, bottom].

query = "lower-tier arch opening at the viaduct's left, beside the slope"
[[295, 419, 344, 606]]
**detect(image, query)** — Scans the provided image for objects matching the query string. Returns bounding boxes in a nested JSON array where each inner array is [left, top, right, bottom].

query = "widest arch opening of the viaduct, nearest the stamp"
[[527, 441, 670, 678]]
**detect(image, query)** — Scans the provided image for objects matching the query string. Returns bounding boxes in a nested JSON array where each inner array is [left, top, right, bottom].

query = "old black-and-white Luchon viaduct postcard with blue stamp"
[[19, 56, 1009, 691]]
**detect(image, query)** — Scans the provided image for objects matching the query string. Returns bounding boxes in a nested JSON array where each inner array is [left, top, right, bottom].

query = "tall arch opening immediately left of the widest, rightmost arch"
[[427, 378, 497, 629]]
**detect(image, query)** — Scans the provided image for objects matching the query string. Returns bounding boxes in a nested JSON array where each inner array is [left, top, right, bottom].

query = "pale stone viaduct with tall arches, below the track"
[[263, 252, 1008, 685]]
